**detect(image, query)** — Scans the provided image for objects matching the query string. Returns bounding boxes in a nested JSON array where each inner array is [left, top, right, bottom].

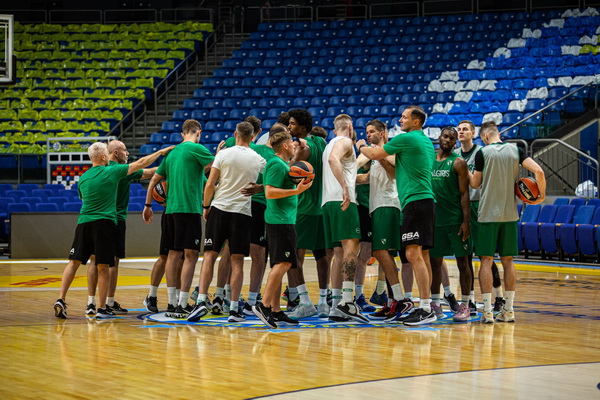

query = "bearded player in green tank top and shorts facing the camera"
[[429, 127, 473, 322]]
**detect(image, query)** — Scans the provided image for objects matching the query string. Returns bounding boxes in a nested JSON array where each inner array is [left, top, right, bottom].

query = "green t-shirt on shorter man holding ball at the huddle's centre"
[[264, 156, 298, 225]]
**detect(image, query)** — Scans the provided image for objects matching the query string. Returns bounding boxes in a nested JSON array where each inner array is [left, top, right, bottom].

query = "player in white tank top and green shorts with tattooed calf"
[[322, 114, 369, 323]]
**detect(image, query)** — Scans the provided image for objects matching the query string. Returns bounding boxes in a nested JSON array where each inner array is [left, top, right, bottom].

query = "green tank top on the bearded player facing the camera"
[[431, 153, 463, 226]]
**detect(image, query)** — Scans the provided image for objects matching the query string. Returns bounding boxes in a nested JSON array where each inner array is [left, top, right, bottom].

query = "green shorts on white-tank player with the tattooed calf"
[[324, 201, 361, 249]]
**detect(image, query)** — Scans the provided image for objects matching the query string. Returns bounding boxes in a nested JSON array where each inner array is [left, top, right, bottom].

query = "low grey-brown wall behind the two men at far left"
[[10, 212, 162, 259]]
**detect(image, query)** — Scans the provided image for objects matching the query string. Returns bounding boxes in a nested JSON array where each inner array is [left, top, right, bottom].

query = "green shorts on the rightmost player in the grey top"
[[475, 221, 519, 257]]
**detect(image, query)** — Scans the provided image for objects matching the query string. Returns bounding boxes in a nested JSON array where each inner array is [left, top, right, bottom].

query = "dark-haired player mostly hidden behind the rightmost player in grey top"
[[454, 121, 505, 315]]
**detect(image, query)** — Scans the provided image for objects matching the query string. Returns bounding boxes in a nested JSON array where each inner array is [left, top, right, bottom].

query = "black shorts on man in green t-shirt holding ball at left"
[[161, 213, 202, 251]]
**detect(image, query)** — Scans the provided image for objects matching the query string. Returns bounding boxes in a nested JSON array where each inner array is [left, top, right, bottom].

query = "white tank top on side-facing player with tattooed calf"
[[321, 136, 356, 206]]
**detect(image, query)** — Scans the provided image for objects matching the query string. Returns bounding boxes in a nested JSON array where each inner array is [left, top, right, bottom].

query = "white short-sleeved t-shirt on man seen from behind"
[[211, 146, 267, 216]]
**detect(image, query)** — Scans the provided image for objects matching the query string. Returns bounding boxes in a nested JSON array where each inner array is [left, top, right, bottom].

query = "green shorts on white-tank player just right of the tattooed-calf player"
[[371, 207, 402, 250]]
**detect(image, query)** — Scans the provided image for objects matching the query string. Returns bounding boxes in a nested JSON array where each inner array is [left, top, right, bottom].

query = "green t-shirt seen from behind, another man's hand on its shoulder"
[[156, 142, 214, 214]]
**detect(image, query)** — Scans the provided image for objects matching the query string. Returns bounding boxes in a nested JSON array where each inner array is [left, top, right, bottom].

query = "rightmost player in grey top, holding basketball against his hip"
[[470, 121, 546, 324]]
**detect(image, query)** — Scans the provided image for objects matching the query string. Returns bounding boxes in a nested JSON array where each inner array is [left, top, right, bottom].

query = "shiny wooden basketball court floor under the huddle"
[[0, 260, 600, 400]]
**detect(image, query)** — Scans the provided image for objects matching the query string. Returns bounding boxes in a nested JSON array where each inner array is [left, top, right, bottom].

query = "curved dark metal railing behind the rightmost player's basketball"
[[529, 138, 600, 196]]
